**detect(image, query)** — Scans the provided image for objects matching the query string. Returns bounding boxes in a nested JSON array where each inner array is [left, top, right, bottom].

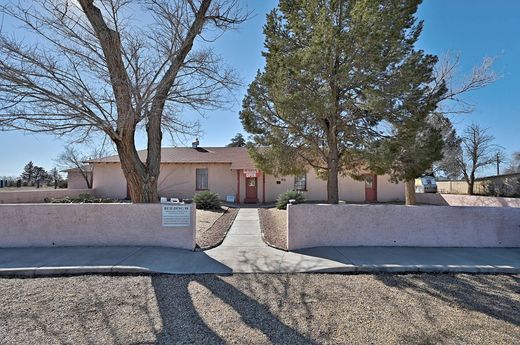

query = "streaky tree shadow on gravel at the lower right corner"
[[376, 274, 520, 326]]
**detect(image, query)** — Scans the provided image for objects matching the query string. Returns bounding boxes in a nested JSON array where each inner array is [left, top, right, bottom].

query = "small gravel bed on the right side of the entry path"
[[258, 208, 287, 250]]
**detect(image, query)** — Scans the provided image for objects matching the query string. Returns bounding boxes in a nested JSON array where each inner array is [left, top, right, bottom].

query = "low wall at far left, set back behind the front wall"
[[0, 188, 95, 204]]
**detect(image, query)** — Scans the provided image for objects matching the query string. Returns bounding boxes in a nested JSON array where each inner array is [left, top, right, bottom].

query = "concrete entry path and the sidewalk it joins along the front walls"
[[0, 209, 520, 276]]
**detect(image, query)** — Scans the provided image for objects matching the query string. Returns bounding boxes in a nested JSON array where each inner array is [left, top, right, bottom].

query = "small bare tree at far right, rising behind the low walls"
[[457, 124, 499, 195]]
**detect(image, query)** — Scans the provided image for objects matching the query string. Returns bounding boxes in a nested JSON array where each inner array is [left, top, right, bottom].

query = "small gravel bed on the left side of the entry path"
[[196, 207, 238, 249]]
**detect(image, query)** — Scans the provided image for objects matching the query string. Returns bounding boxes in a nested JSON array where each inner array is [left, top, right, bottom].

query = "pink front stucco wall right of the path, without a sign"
[[287, 204, 520, 250]]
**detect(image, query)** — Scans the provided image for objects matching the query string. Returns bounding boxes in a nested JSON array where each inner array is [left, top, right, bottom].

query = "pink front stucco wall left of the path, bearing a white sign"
[[0, 204, 196, 250]]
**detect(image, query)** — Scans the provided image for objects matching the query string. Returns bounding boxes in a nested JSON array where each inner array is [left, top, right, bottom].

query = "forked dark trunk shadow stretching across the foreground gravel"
[[152, 275, 315, 344]]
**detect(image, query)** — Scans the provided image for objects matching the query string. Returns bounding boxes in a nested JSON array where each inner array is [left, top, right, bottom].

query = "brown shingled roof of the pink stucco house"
[[88, 147, 255, 169]]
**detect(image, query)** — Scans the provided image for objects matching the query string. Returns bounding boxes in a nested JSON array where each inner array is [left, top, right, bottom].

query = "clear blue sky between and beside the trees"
[[0, 0, 520, 176]]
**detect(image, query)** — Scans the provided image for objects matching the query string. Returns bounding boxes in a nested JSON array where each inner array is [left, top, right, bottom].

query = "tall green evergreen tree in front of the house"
[[240, 0, 446, 203]]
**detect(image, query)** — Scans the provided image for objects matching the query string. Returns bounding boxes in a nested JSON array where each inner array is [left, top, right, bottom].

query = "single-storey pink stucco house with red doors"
[[89, 146, 404, 203]]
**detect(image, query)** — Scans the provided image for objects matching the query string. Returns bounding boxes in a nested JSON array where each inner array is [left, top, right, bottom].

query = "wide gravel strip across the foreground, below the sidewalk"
[[0, 274, 520, 344]]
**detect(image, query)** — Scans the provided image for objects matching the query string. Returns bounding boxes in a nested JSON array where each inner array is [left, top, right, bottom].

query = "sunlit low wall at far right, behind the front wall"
[[416, 193, 520, 207]]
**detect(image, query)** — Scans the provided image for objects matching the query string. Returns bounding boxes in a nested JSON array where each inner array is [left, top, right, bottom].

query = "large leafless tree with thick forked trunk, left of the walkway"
[[0, 0, 247, 202]]
